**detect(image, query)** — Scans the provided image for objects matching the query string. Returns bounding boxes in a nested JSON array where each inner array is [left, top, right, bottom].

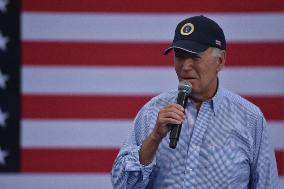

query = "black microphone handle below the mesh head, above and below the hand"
[[169, 91, 189, 149]]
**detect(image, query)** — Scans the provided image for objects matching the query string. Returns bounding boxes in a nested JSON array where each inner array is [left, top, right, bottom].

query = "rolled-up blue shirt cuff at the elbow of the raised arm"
[[125, 145, 156, 180]]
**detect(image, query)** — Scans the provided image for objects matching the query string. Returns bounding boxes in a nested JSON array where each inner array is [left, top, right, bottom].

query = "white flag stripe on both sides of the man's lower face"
[[22, 66, 284, 96]]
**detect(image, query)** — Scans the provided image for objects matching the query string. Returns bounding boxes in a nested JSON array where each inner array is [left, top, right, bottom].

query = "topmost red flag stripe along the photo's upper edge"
[[22, 0, 284, 13]]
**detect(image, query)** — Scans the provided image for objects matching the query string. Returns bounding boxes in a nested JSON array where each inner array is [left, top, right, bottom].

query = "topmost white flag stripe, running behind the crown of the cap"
[[21, 12, 284, 42]]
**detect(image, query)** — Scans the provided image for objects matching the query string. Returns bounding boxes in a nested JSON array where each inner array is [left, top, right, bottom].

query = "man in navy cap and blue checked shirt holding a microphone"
[[112, 16, 278, 189]]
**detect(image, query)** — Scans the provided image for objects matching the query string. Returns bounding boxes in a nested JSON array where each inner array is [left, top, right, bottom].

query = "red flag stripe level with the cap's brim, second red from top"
[[22, 41, 284, 66]]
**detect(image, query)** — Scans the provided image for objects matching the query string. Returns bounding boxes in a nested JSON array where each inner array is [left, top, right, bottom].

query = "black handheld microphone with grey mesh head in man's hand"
[[169, 80, 192, 149]]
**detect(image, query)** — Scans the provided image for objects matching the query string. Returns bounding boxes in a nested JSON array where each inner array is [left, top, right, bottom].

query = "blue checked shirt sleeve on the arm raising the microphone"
[[111, 103, 156, 189]]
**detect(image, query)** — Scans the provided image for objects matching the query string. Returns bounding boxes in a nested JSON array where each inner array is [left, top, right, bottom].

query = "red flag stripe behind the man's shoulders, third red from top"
[[22, 95, 284, 120]]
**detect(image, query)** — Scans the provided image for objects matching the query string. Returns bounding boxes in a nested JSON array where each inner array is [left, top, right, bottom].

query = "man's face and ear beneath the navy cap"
[[174, 48, 225, 100]]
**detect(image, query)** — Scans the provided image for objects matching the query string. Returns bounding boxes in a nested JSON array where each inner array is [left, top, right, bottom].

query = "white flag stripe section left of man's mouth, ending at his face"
[[22, 66, 177, 95]]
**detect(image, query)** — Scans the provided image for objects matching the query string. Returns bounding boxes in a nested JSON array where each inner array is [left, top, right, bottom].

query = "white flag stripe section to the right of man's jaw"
[[220, 67, 284, 96]]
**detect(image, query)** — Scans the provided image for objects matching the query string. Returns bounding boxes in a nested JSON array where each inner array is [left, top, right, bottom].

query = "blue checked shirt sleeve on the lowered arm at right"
[[252, 116, 279, 189]]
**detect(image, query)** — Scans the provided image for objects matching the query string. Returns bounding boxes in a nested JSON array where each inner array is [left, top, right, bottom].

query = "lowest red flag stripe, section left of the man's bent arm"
[[21, 148, 118, 173]]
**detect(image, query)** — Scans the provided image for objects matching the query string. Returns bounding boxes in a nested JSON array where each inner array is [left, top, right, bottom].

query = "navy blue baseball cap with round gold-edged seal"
[[164, 15, 226, 55]]
